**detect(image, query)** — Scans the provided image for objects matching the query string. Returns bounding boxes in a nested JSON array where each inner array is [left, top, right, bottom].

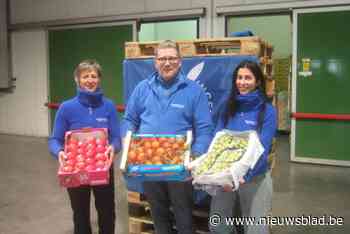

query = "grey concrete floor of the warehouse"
[[0, 134, 350, 234]]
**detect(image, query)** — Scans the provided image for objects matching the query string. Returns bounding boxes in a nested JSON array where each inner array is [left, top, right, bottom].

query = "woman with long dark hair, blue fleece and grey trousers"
[[210, 60, 277, 234]]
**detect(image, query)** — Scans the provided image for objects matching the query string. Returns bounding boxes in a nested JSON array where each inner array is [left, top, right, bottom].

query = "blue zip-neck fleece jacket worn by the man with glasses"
[[124, 72, 213, 155]]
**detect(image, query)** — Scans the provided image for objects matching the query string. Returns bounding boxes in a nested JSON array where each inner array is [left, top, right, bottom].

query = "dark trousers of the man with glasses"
[[143, 181, 193, 234]]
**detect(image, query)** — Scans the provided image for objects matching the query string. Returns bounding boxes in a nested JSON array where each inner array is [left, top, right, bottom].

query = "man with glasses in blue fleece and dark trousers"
[[125, 40, 212, 234]]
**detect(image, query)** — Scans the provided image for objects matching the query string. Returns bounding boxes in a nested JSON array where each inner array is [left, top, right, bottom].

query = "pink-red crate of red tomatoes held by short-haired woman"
[[57, 128, 112, 187]]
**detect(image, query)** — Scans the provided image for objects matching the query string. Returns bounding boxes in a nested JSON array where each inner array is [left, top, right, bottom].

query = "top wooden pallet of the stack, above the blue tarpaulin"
[[125, 36, 273, 59]]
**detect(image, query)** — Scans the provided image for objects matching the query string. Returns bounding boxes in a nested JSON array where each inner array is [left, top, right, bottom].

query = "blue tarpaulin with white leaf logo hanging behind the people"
[[123, 55, 258, 203]]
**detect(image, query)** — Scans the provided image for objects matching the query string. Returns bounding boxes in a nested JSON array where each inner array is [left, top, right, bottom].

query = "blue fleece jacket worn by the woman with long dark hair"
[[215, 91, 277, 182]]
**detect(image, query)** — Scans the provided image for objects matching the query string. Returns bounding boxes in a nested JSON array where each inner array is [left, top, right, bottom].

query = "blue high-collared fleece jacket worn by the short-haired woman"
[[49, 89, 121, 158]]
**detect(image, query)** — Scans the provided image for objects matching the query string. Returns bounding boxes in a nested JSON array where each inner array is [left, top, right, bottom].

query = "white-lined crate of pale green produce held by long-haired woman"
[[190, 129, 263, 195]]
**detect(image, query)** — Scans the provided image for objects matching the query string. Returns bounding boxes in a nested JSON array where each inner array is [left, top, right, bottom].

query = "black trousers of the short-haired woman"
[[67, 168, 115, 234]]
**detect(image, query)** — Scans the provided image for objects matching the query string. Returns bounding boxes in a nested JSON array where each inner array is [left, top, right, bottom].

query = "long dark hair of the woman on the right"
[[224, 60, 267, 132]]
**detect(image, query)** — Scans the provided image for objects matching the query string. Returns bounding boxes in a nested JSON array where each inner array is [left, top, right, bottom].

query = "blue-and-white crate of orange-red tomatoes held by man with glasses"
[[120, 131, 192, 181]]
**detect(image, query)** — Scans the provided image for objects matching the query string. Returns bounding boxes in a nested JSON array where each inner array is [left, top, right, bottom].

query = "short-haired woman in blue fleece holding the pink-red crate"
[[49, 60, 121, 234]]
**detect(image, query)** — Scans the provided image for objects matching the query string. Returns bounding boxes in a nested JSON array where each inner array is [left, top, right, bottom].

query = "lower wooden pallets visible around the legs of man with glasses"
[[128, 191, 209, 234]]
